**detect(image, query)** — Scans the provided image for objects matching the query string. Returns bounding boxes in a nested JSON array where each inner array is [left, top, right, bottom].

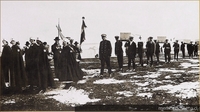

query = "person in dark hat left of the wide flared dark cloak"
[[51, 37, 61, 78]]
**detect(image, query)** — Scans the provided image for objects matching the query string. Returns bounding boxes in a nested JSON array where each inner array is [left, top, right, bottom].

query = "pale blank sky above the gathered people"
[[1, 1, 199, 57]]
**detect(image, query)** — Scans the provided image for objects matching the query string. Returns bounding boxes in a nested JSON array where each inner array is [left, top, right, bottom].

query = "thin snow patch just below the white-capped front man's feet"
[[93, 78, 125, 84]]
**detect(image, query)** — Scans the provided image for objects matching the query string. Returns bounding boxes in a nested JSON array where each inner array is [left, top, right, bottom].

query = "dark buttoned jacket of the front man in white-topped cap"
[[99, 40, 112, 59]]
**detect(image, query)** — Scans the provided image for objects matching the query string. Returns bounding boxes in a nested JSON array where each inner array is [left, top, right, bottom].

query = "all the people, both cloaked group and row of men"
[[1, 34, 198, 93]]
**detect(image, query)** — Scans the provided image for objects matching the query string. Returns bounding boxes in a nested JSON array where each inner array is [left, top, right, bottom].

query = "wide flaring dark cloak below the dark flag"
[[59, 46, 83, 82]]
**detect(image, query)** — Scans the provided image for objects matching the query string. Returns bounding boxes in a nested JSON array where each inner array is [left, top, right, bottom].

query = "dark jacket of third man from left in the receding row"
[[126, 41, 137, 58]]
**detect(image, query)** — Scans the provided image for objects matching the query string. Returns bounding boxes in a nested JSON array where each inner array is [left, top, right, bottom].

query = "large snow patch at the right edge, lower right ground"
[[153, 82, 199, 98]]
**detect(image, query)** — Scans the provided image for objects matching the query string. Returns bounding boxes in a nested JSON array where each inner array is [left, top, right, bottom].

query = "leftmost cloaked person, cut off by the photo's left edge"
[[1, 40, 12, 93]]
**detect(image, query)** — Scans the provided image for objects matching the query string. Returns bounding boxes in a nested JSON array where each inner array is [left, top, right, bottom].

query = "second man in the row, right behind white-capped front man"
[[115, 36, 123, 71]]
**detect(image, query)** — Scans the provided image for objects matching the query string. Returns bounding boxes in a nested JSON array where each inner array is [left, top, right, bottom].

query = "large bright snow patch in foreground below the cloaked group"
[[44, 86, 101, 106]]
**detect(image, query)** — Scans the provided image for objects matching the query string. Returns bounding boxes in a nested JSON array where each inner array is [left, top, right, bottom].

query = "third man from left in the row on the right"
[[125, 36, 136, 71]]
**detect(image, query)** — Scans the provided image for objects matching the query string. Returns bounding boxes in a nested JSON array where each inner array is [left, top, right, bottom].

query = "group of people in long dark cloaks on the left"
[[1, 37, 83, 93]]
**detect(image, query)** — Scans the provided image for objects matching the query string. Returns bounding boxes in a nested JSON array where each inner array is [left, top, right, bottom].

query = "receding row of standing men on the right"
[[99, 34, 198, 77]]
